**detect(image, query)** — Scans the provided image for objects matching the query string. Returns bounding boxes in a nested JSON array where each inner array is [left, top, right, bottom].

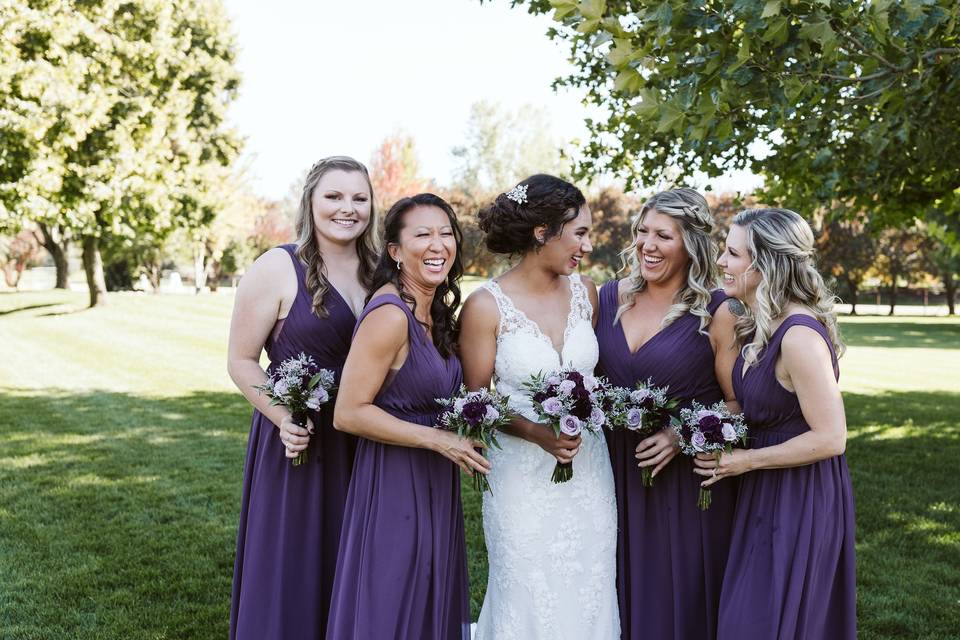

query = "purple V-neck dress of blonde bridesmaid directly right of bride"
[[597, 280, 736, 640]]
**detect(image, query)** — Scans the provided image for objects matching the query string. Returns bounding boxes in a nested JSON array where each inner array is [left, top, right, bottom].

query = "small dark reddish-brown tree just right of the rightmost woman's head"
[[817, 219, 877, 315]]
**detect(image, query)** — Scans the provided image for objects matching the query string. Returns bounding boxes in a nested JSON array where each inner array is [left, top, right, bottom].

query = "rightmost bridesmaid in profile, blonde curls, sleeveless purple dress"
[[697, 209, 857, 640]]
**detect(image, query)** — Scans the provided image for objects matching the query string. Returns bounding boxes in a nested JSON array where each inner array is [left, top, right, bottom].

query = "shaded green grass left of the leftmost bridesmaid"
[[0, 388, 251, 639]]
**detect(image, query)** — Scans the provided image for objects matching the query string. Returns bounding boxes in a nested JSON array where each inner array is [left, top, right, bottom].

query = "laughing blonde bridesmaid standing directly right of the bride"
[[597, 189, 736, 640]]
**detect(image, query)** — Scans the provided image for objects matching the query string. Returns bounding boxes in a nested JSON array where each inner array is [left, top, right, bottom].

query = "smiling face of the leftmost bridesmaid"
[[311, 169, 372, 245]]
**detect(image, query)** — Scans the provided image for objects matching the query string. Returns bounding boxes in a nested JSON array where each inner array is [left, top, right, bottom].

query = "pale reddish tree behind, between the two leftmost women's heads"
[[370, 132, 430, 213]]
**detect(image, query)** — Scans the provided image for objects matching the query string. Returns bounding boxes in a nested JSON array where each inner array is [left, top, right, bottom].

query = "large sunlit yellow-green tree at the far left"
[[0, 0, 239, 306]]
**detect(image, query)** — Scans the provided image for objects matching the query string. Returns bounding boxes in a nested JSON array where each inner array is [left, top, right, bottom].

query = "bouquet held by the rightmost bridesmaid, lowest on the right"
[[674, 401, 747, 510]]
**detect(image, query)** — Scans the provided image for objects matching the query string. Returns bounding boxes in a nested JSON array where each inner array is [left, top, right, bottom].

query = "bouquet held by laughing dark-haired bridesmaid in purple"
[[437, 385, 510, 493]]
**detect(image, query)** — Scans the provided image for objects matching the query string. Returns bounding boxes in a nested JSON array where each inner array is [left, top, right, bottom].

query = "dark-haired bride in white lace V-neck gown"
[[460, 175, 620, 640]]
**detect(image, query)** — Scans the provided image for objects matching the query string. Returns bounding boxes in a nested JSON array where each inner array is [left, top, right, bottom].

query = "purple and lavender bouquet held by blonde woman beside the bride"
[[603, 378, 680, 487]]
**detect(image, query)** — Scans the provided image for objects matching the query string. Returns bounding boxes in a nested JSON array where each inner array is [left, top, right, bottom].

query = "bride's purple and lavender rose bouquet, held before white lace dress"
[[523, 369, 607, 483]]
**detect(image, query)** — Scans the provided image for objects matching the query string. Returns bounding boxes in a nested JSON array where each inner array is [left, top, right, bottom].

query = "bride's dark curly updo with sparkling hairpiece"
[[478, 173, 587, 255]]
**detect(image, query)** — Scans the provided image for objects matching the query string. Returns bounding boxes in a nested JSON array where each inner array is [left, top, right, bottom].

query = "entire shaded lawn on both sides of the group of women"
[[0, 388, 960, 640]]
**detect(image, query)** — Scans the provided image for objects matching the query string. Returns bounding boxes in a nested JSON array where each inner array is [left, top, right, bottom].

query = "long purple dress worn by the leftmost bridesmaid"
[[230, 245, 356, 640]]
